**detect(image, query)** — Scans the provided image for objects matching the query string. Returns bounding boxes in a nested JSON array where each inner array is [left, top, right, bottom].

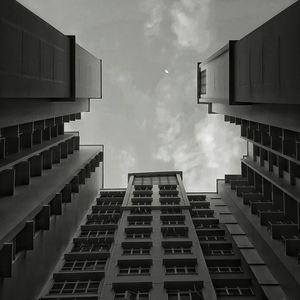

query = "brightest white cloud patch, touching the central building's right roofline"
[[155, 115, 246, 191]]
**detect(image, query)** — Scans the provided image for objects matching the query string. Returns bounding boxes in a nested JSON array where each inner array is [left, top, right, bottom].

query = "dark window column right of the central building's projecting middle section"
[[188, 195, 255, 298]]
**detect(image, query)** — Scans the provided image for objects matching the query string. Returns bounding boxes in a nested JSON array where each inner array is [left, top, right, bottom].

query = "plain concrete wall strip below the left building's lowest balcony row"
[[0, 163, 102, 300]]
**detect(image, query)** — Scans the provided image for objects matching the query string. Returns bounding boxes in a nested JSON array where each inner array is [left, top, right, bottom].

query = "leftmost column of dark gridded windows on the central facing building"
[[41, 191, 124, 299]]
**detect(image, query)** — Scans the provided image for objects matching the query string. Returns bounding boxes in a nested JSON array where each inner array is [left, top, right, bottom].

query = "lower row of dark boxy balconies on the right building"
[[226, 167, 300, 256]]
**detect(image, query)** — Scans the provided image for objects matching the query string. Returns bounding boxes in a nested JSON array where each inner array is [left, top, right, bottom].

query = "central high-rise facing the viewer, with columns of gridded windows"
[[40, 172, 286, 300]]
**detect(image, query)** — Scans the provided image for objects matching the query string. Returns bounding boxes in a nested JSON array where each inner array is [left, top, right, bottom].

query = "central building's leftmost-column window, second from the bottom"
[[61, 260, 106, 272]]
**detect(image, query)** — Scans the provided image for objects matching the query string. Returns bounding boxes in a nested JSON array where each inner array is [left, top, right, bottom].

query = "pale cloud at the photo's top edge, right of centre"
[[170, 0, 210, 52]]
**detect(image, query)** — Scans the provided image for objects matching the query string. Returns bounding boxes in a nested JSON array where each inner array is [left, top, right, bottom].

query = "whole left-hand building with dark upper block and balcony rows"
[[0, 0, 104, 300]]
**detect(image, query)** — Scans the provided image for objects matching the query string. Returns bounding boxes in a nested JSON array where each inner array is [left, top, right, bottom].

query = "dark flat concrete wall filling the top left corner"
[[0, 1, 71, 98]]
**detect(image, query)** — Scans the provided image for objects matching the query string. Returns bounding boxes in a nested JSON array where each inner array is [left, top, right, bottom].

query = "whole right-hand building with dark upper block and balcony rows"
[[197, 1, 300, 299]]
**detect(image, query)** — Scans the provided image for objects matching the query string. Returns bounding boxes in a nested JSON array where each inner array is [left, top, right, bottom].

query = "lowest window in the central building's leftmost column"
[[49, 280, 100, 295]]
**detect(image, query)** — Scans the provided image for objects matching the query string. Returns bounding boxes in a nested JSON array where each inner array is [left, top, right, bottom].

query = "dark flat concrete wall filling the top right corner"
[[234, 1, 300, 104]]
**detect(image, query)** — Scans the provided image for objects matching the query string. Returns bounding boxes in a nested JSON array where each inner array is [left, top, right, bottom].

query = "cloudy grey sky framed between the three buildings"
[[19, 0, 295, 191]]
